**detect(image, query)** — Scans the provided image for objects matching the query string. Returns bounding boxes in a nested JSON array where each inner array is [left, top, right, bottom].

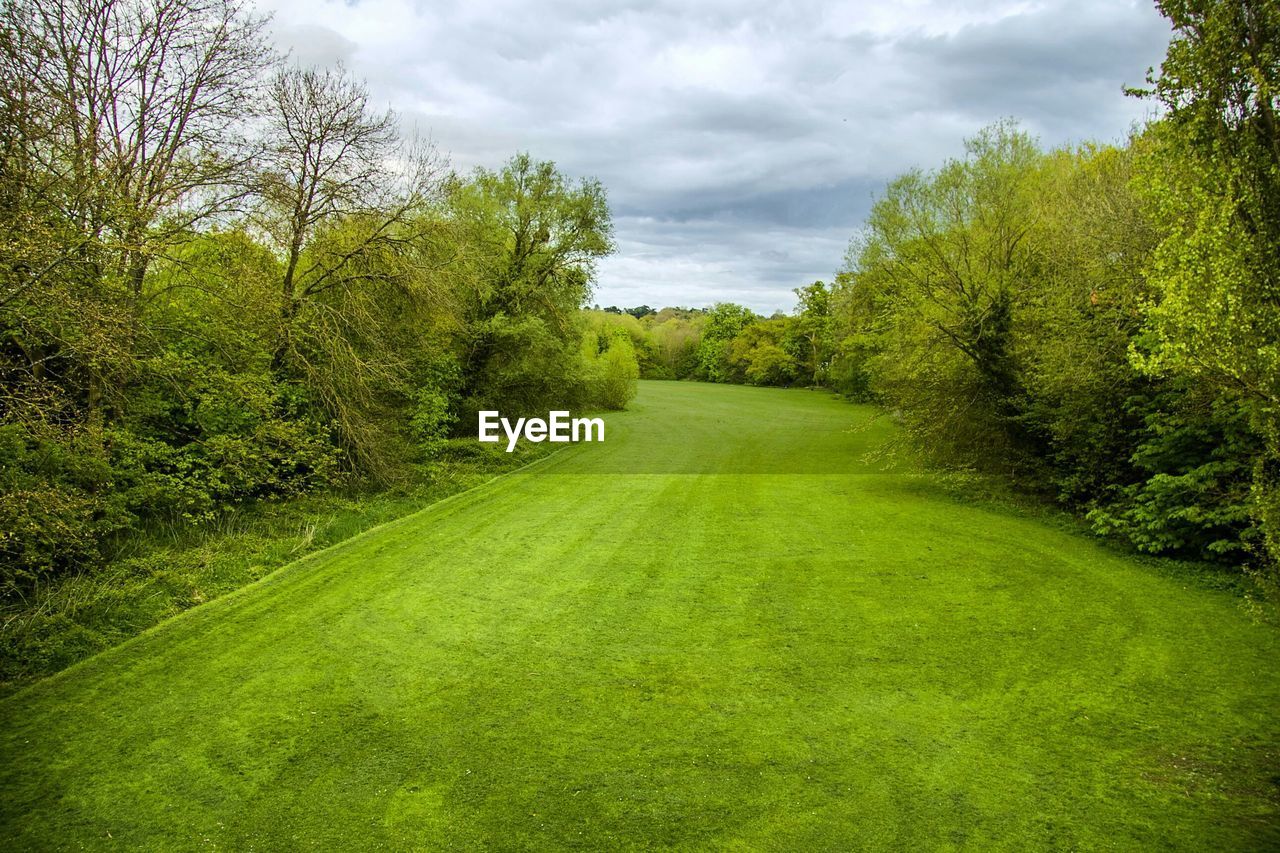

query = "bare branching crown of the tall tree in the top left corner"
[[4, 0, 271, 296]]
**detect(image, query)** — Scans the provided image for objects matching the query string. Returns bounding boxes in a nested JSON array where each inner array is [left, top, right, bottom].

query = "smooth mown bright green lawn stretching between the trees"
[[0, 383, 1280, 850]]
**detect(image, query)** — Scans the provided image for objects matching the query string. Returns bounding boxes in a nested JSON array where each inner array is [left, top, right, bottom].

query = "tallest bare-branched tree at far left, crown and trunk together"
[[0, 0, 274, 411]]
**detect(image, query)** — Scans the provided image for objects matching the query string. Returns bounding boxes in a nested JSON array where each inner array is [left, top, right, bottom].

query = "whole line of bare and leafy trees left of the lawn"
[[0, 0, 637, 594]]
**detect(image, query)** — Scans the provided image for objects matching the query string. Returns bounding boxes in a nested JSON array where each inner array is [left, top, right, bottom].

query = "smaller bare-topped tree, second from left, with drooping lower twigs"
[[260, 67, 449, 474]]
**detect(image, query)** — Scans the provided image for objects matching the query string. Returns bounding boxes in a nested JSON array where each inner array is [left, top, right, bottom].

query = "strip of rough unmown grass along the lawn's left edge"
[[0, 439, 549, 697]]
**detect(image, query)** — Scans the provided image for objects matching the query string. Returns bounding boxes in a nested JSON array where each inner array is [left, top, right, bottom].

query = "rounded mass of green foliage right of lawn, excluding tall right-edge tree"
[[831, 117, 1268, 565]]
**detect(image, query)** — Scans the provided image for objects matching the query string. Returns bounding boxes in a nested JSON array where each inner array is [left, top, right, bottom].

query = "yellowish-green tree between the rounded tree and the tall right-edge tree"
[[1015, 146, 1161, 508]]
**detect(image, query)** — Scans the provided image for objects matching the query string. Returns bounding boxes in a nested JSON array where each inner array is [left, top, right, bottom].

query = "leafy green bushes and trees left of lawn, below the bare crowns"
[[0, 119, 614, 597]]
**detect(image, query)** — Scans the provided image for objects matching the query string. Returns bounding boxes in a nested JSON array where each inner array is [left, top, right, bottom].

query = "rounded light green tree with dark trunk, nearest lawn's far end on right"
[[844, 117, 1041, 465]]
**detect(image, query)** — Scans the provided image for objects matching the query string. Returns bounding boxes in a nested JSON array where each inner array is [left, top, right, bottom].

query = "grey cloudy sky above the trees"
[[260, 0, 1169, 313]]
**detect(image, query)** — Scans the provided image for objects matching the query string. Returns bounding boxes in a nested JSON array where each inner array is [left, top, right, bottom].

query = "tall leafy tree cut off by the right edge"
[[1137, 0, 1280, 578]]
